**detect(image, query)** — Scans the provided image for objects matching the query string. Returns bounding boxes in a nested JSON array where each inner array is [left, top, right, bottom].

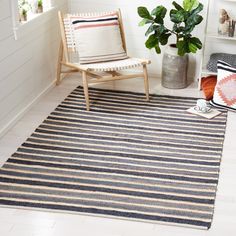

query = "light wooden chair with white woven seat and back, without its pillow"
[[57, 10, 151, 111]]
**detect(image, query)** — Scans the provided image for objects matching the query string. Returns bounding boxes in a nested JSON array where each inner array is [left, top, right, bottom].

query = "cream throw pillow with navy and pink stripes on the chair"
[[71, 12, 128, 64]]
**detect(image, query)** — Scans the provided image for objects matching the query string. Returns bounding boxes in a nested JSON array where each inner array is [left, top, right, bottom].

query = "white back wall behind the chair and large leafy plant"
[[68, 0, 208, 79]]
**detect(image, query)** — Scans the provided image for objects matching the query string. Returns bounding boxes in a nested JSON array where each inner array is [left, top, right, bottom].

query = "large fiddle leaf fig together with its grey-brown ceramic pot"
[[138, 0, 203, 88]]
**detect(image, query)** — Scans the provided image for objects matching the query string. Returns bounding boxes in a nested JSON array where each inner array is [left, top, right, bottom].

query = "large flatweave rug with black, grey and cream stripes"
[[0, 87, 227, 229]]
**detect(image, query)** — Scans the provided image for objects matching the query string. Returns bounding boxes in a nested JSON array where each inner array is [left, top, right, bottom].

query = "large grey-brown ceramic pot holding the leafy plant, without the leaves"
[[162, 44, 188, 89]]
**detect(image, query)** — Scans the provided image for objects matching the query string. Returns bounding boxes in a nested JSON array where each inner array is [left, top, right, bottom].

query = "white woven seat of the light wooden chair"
[[78, 58, 150, 72]]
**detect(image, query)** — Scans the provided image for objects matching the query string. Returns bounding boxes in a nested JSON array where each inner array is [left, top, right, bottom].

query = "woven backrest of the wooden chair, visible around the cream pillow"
[[58, 9, 127, 62]]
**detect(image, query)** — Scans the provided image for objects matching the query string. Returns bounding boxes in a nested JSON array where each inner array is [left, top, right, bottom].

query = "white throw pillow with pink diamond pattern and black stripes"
[[211, 61, 236, 111]]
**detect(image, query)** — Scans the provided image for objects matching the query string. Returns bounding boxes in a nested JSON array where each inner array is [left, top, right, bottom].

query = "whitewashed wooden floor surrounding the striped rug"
[[0, 78, 236, 236]]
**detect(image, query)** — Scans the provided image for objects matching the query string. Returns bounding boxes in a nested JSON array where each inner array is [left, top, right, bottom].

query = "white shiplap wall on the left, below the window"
[[0, 0, 67, 136]]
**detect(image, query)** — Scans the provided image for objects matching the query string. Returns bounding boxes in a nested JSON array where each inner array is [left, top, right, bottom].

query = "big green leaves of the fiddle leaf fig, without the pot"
[[138, 0, 203, 56]]
